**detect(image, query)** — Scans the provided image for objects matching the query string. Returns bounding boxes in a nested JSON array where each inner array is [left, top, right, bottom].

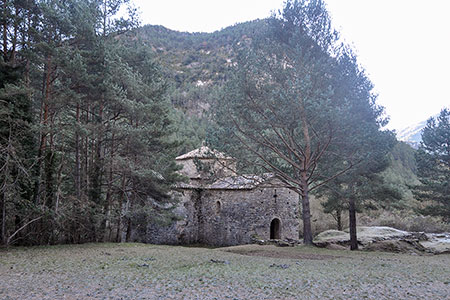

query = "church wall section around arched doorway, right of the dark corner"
[[199, 188, 299, 246]]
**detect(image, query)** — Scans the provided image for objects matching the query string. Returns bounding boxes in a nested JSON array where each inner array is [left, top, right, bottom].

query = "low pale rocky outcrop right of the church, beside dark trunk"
[[314, 226, 450, 254]]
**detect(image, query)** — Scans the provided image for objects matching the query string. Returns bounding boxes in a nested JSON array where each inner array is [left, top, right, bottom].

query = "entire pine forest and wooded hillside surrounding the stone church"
[[0, 0, 450, 247]]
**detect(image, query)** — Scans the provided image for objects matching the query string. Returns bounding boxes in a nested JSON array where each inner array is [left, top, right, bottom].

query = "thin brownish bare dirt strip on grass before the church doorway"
[[220, 245, 341, 260]]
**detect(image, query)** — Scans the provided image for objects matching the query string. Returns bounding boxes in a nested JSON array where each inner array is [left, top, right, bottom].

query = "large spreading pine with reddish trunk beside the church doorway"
[[212, 1, 346, 244]]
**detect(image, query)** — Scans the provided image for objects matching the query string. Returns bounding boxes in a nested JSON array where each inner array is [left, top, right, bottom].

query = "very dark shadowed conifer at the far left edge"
[[0, 59, 36, 245]]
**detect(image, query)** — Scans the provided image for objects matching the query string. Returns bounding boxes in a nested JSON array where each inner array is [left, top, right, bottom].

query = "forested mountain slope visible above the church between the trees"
[[137, 20, 267, 153]]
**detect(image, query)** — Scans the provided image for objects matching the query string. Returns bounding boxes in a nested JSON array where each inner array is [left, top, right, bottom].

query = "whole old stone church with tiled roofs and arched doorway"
[[147, 146, 299, 246]]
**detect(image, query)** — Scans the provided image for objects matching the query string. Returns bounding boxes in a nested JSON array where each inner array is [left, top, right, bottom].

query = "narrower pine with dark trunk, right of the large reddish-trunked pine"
[[322, 48, 401, 250]]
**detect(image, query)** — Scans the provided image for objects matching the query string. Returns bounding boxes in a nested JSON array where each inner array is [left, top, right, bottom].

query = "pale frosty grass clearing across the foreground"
[[0, 244, 450, 300]]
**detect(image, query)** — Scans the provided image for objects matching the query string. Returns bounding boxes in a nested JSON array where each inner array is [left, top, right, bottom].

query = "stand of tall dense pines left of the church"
[[0, 0, 179, 244]]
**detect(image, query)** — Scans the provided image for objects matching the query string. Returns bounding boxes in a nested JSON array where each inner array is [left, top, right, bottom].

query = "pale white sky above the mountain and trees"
[[133, 0, 450, 129]]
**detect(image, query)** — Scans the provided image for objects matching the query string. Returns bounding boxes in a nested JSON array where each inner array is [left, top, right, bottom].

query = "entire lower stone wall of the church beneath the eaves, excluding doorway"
[[147, 187, 299, 246]]
